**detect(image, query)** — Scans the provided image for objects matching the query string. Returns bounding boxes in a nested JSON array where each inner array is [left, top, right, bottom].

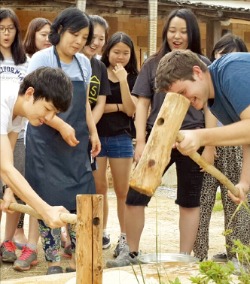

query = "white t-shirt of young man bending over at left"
[[0, 81, 27, 135]]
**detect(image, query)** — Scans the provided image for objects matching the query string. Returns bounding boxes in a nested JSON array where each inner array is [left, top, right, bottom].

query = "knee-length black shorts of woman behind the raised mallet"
[[126, 148, 204, 208]]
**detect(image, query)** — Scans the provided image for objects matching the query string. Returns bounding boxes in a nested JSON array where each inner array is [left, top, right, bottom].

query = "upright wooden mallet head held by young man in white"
[[76, 194, 103, 284]]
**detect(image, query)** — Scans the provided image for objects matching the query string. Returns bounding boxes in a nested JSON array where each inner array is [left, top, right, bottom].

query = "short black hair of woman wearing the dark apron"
[[49, 7, 93, 45]]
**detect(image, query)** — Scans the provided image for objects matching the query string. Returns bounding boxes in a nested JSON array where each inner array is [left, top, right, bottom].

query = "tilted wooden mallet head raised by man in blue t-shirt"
[[130, 93, 190, 196]]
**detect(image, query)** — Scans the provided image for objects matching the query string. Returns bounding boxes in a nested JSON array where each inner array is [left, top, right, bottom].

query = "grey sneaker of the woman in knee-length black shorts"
[[106, 244, 139, 268]]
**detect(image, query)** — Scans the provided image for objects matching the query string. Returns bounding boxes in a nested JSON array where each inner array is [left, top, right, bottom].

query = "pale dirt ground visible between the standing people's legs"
[[0, 182, 225, 281]]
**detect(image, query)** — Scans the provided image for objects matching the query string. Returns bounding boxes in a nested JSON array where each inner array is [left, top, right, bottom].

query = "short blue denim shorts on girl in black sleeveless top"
[[98, 134, 134, 158]]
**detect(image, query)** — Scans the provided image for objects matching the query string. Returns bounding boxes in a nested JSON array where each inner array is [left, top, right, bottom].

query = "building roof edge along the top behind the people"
[[1, 0, 250, 21]]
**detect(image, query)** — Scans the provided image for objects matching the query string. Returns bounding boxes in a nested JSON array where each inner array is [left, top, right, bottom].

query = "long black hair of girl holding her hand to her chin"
[[101, 32, 138, 74]]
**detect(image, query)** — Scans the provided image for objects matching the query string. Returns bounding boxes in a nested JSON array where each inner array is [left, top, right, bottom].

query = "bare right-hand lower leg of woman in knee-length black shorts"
[[179, 206, 200, 254]]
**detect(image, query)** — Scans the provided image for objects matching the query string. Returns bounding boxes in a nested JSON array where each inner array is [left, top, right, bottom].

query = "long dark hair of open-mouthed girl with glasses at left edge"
[[0, 8, 27, 65]]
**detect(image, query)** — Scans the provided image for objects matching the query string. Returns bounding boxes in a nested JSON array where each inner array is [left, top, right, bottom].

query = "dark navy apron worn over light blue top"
[[25, 48, 95, 210]]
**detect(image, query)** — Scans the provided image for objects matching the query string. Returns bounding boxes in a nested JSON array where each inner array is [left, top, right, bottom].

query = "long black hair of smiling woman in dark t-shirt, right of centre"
[[155, 9, 202, 59]]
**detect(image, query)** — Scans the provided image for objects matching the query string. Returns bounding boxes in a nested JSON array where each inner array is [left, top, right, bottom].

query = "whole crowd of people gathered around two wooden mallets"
[[0, 3, 250, 274]]
